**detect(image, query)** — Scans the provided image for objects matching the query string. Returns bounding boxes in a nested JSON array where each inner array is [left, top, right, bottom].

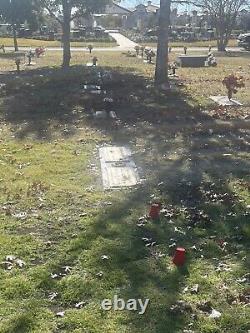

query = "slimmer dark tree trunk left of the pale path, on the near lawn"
[[62, 0, 71, 68]]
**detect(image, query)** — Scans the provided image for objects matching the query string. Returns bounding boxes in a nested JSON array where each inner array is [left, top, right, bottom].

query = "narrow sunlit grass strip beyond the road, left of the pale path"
[[0, 37, 117, 48]]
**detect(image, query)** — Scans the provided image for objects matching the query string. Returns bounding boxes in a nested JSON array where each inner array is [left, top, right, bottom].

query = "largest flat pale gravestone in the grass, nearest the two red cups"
[[99, 146, 140, 189]]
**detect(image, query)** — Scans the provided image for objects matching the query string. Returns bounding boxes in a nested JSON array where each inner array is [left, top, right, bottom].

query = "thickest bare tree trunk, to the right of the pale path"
[[155, 0, 171, 85]]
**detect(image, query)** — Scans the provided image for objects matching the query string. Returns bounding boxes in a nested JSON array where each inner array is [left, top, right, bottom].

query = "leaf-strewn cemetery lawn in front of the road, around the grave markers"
[[0, 52, 250, 333]]
